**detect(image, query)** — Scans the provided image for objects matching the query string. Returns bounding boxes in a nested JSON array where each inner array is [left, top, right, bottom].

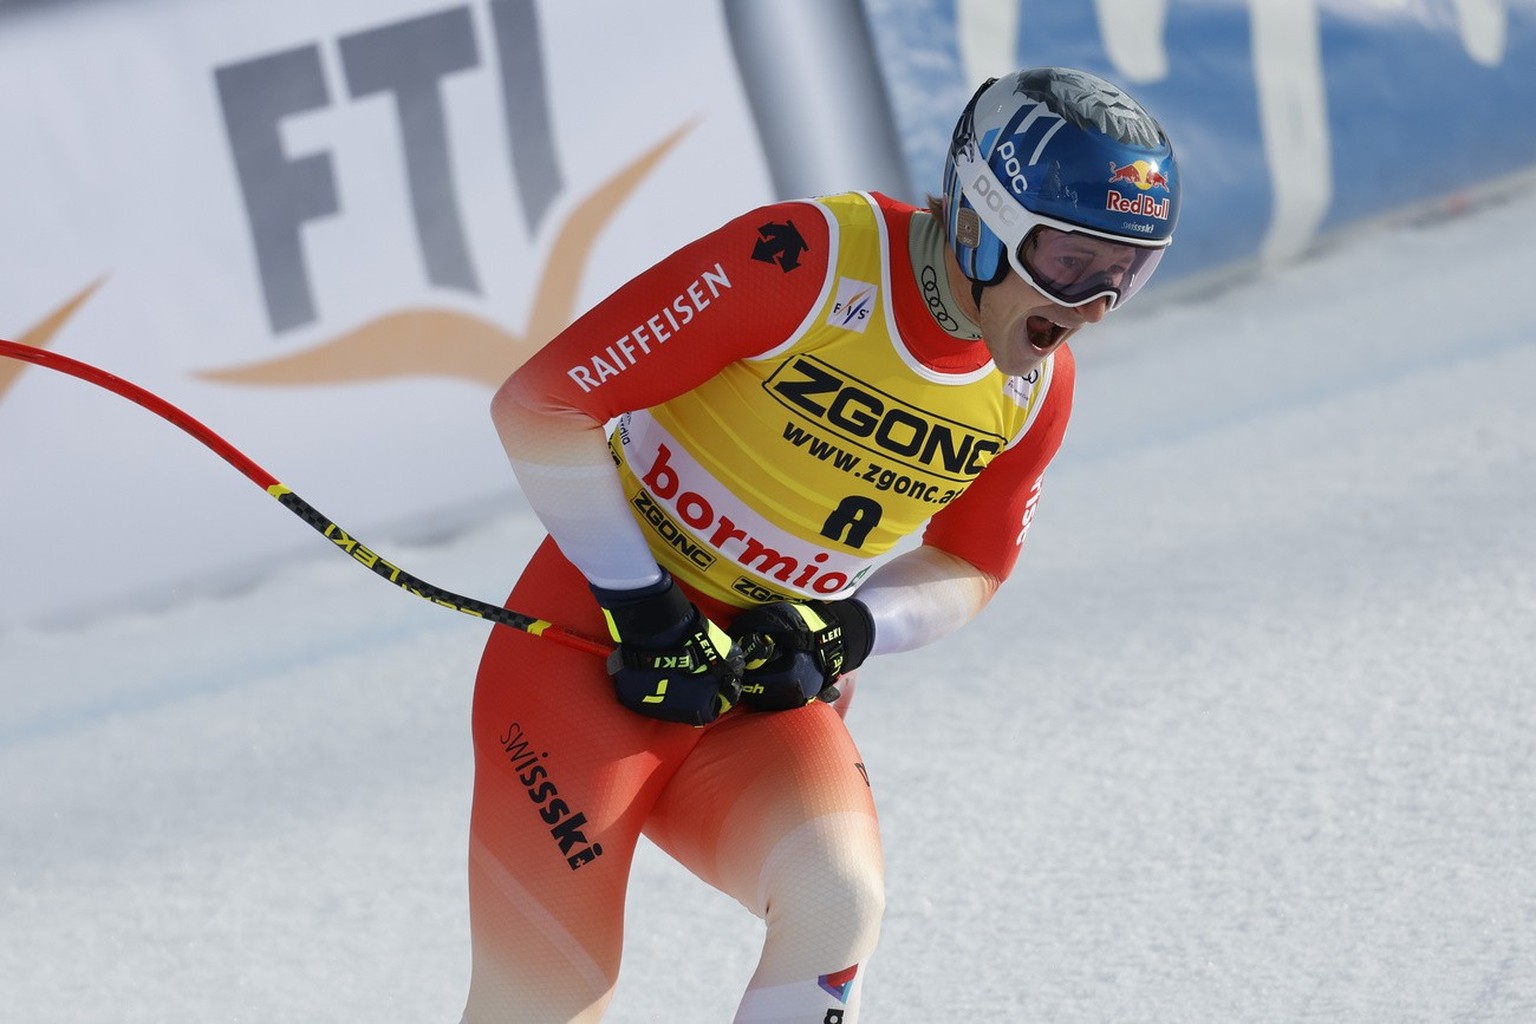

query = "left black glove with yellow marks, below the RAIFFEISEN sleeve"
[[591, 574, 742, 726]]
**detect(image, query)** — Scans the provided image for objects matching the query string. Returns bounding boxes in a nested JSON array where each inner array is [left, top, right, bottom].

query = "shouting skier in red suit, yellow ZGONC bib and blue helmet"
[[464, 68, 1180, 1024]]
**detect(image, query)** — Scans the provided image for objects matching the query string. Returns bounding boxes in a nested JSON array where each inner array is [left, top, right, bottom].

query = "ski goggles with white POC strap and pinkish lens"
[[955, 144, 1170, 309]]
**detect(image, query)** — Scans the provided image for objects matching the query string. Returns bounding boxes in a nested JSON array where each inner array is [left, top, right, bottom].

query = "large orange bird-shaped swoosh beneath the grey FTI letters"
[[197, 121, 696, 387]]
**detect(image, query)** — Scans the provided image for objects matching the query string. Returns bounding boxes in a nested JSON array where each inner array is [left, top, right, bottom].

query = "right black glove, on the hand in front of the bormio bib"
[[730, 597, 874, 711]]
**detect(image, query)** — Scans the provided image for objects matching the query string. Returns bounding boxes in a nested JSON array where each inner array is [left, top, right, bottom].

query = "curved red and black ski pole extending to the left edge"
[[0, 338, 613, 657]]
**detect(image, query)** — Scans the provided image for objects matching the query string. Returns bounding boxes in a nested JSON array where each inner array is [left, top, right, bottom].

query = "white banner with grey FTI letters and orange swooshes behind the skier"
[[0, 0, 771, 622]]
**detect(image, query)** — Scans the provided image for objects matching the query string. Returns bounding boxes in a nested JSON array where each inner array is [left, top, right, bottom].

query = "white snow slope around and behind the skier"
[[0, 186, 1536, 1024]]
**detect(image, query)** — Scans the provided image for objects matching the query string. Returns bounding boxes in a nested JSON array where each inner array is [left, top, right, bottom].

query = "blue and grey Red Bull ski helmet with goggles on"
[[943, 68, 1180, 307]]
